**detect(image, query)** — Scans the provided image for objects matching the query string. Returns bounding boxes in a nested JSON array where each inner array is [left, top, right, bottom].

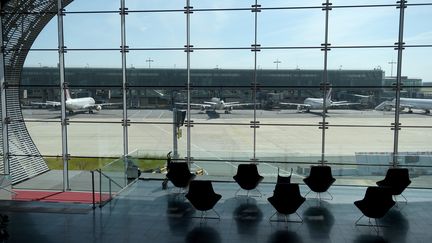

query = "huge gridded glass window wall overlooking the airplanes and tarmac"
[[3, 0, 432, 190]]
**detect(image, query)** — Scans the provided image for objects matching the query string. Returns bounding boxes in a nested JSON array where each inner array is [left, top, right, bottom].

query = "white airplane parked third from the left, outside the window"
[[279, 88, 359, 112]]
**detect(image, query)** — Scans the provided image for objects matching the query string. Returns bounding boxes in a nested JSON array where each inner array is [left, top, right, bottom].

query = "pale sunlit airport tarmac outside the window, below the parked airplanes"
[[15, 109, 432, 190]]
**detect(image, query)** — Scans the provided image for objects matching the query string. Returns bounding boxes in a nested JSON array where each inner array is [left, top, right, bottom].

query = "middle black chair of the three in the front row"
[[267, 183, 306, 223]]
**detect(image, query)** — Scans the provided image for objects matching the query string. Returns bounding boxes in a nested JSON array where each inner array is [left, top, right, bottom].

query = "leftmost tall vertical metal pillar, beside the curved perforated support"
[[57, 0, 70, 191]]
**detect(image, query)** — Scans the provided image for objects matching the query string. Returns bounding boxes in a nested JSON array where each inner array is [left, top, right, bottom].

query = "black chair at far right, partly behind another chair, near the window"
[[377, 168, 411, 203]]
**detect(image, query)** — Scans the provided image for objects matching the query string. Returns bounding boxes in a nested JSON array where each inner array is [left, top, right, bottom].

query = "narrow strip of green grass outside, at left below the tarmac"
[[45, 157, 166, 171]]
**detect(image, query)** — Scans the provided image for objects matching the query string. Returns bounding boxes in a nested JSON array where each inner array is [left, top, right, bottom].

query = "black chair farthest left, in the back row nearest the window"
[[166, 162, 196, 193]]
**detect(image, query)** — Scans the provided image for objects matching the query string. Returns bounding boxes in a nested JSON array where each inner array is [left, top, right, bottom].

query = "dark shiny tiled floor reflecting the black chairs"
[[0, 180, 432, 243]]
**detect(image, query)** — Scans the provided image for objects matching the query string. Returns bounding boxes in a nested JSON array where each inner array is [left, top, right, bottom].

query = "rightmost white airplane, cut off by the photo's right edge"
[[375, 98, 432, 114]]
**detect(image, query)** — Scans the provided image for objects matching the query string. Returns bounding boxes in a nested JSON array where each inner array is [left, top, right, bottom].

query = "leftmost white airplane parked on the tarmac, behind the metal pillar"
[[31, 89, 121, 114]]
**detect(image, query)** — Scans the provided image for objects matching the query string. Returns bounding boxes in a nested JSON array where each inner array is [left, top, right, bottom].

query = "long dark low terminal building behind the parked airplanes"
[[20, 67, 394, 108]]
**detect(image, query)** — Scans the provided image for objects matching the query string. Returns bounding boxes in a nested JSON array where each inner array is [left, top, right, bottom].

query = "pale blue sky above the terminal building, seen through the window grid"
[[25, 0, 432, 82]]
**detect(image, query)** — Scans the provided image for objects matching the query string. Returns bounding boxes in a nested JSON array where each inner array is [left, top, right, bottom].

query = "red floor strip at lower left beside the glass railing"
[[12, 190, 109, 204]]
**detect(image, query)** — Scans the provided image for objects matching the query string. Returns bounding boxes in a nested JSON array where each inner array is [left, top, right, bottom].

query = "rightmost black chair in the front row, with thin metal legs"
[[354, 187, 395, 231]]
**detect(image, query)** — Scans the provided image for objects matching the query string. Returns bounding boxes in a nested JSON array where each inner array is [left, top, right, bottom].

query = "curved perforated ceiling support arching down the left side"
[[0, 0, 72, 183]]
